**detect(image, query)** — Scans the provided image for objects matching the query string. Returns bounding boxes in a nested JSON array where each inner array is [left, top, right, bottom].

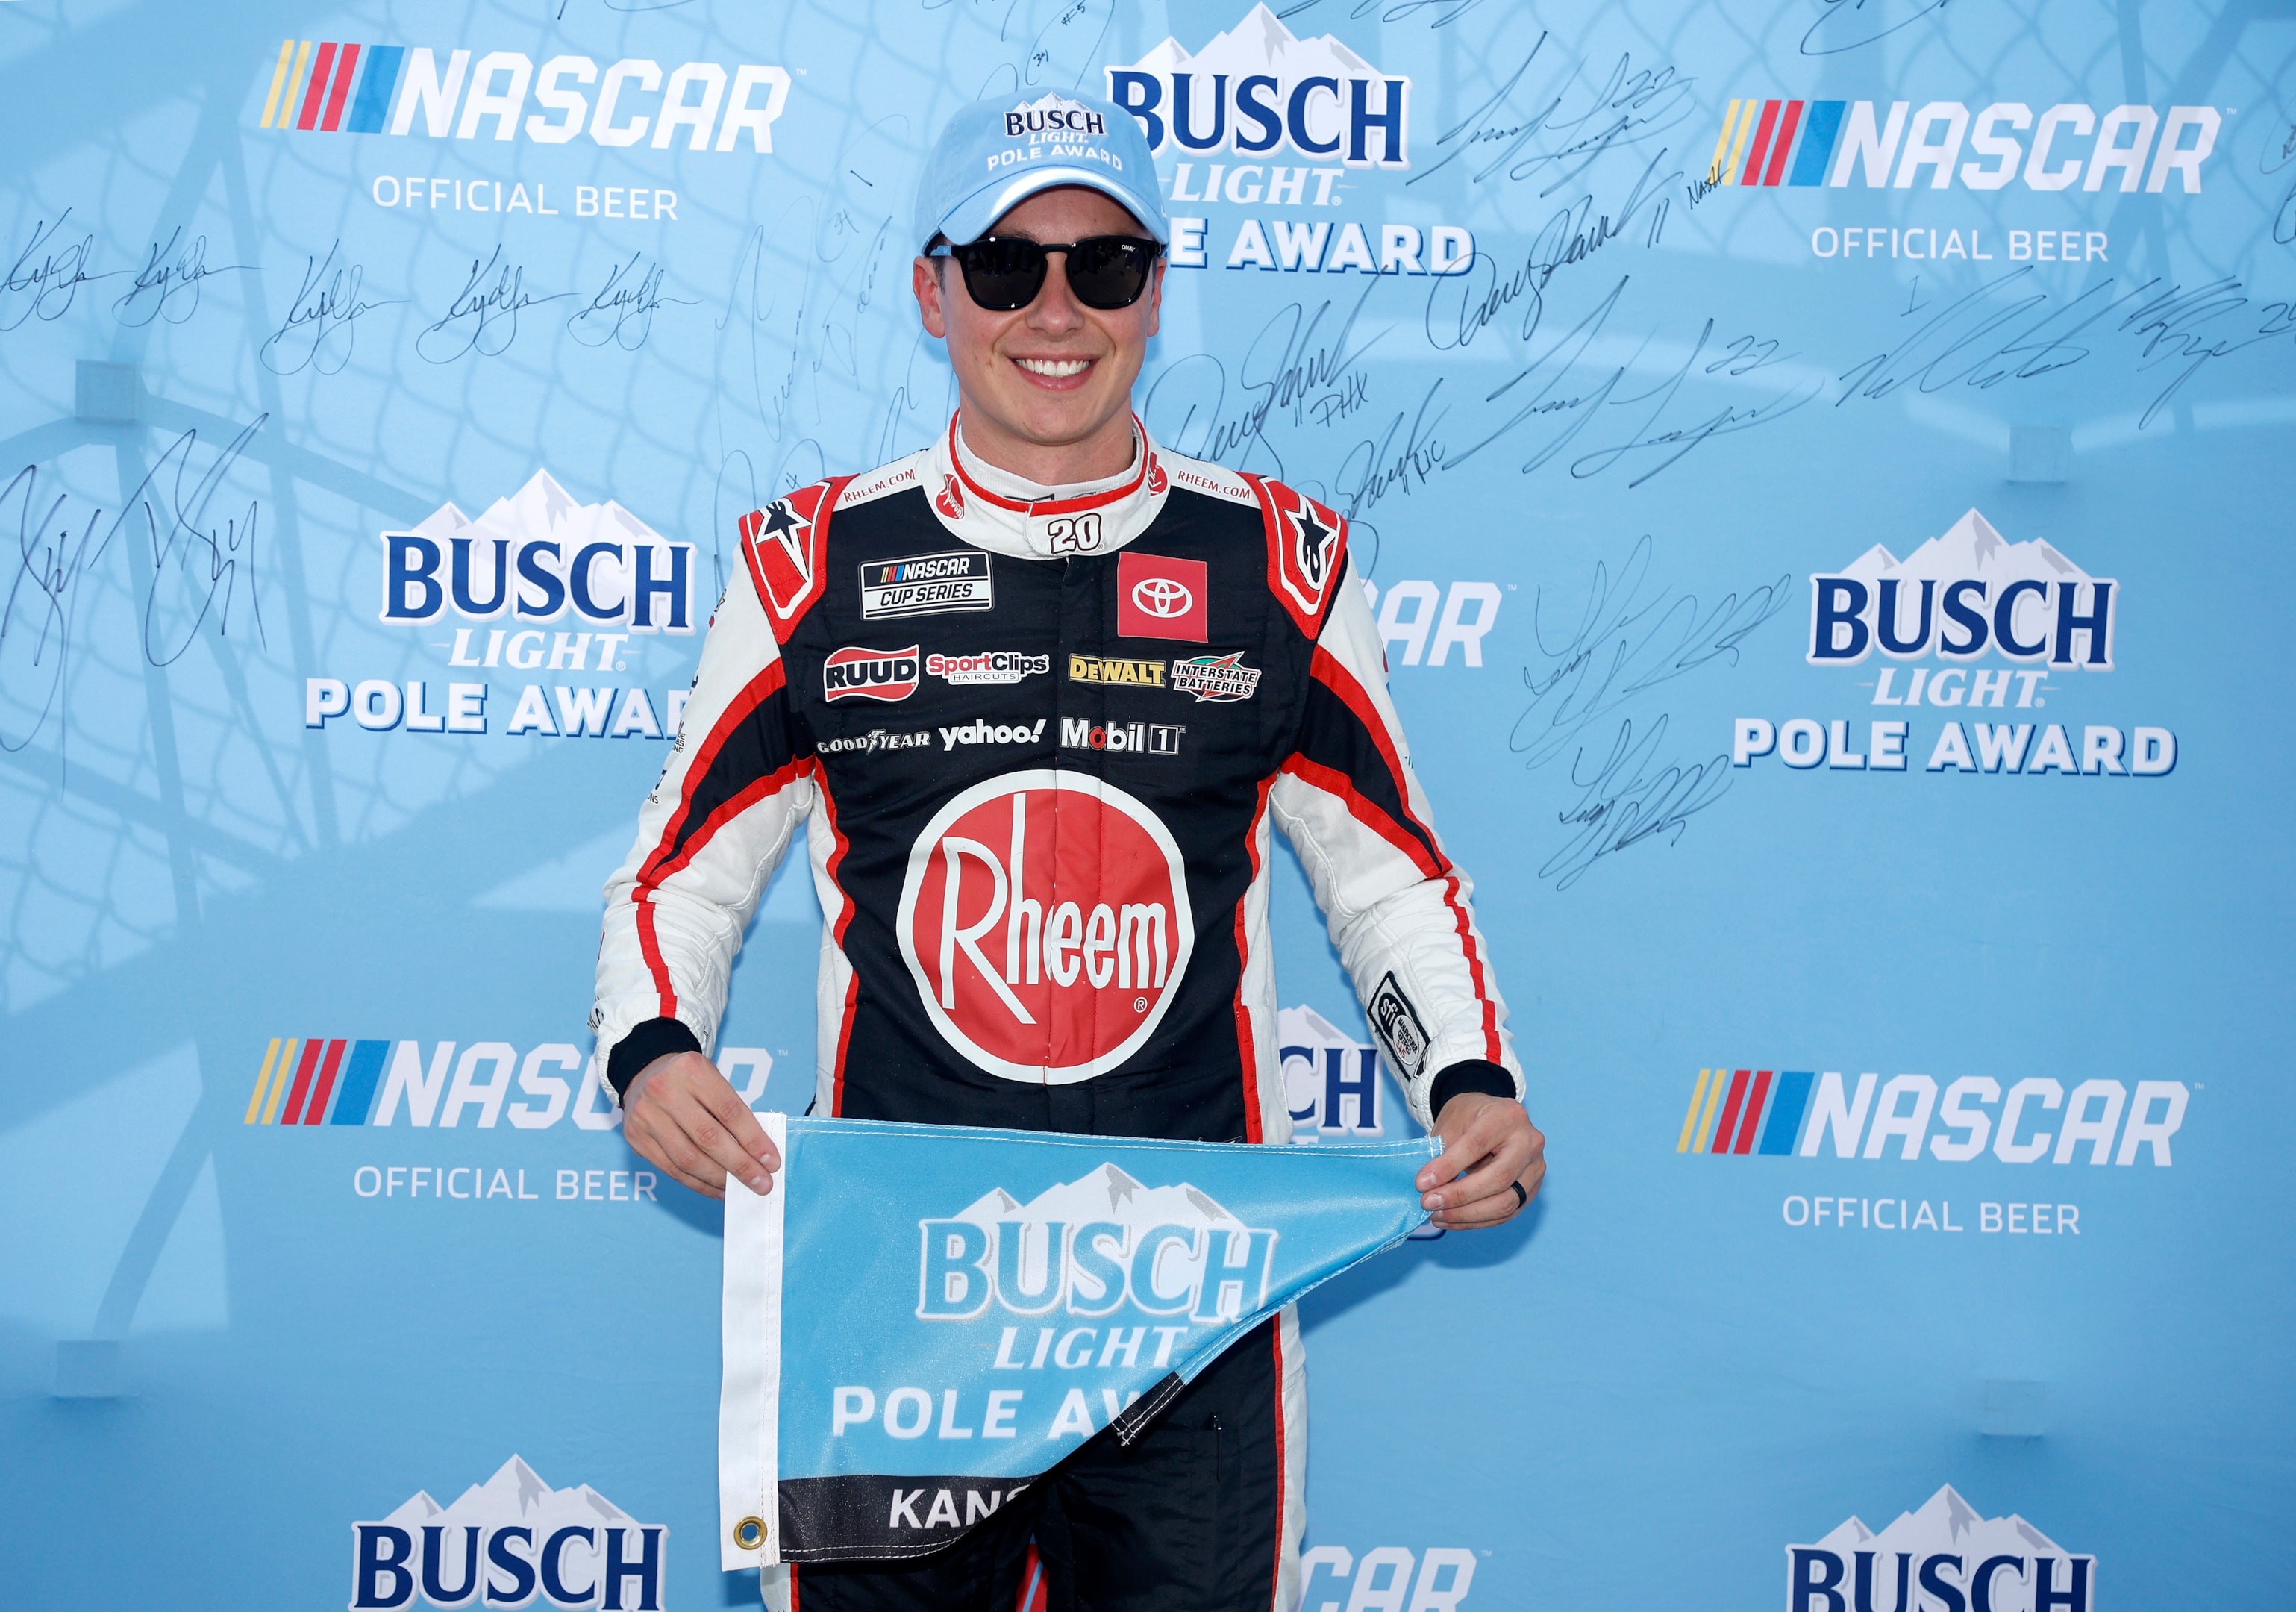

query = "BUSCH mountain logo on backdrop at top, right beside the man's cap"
[[1109, 4, 1412, 168]]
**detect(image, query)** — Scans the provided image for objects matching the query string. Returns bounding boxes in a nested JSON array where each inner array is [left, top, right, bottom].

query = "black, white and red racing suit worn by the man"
[[592, 420, 1522, 1612]]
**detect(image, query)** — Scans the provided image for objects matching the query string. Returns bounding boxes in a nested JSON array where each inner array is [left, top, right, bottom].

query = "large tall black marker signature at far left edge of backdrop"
[[0, 416, 269, 771]]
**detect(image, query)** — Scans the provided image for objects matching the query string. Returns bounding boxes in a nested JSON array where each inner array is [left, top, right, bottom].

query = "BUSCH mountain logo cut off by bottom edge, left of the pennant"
[[349, 1456, 670, 1612]]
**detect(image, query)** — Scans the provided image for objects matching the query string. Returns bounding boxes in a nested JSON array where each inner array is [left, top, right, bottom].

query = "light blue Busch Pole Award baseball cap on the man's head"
[[912, 92, 1171, 250]]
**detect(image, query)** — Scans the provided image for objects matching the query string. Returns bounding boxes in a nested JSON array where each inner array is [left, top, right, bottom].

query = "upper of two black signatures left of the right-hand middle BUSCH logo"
[[1507, 537, 1793, 767]]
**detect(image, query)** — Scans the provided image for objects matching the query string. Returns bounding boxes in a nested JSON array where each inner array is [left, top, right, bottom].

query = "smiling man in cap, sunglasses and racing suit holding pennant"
[[592, 96, 1545, 1612]]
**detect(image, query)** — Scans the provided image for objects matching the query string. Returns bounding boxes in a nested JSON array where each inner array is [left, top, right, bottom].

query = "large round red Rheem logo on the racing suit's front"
[[898, 769, 1194, 1086]]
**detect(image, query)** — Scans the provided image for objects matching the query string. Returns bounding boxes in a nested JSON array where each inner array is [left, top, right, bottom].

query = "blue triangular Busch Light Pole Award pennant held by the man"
[[719, 1113, 1439, 1589]]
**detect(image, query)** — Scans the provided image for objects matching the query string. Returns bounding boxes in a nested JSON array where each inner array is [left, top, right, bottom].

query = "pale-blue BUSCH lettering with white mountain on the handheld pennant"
[[916, 1164, 1277, 1322]]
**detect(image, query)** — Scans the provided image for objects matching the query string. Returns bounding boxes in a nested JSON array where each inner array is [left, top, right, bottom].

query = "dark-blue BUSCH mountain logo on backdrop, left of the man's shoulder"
[[381, 471, 693, 634]]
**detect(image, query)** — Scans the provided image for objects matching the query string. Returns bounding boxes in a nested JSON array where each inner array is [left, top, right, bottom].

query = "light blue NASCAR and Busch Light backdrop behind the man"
[[0, 0, 2296, 1612]]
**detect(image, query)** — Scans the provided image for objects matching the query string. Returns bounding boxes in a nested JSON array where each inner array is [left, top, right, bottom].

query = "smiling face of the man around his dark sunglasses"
[[914, 186, 1164, 448]]
